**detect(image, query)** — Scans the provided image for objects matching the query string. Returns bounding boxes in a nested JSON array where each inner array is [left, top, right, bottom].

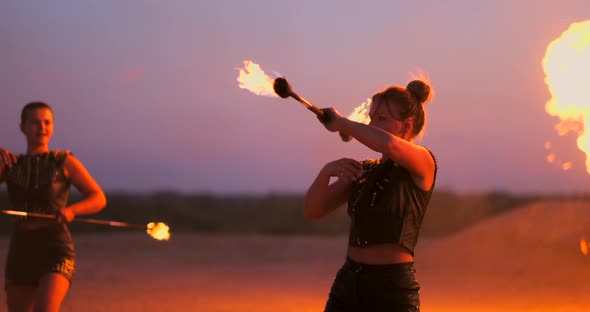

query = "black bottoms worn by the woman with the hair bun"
[[324, 259, 420, 312]]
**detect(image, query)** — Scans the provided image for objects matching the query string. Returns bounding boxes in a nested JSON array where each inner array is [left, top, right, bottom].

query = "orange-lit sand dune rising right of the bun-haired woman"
[[417, 201, 590, 311]]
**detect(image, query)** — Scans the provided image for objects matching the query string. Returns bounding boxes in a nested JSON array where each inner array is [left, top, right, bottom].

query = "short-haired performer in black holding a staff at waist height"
[[0, 102, 106, 312]]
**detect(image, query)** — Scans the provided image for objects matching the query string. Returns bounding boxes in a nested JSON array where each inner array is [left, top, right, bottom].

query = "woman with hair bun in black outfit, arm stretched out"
[[304, 80, 438, 312]]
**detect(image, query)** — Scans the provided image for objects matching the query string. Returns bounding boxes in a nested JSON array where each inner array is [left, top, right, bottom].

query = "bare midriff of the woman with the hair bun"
[[347, 244, 414, 264]]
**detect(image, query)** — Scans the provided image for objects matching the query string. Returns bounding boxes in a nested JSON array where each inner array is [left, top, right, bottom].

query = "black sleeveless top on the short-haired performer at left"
[[6, 151, 71, 214]]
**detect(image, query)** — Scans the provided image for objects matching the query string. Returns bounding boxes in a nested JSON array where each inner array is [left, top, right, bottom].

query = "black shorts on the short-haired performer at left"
[[4, 224, 75, 287]]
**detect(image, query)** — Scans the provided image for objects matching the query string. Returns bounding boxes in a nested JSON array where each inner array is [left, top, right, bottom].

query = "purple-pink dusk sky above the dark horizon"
[[0, 0, 590, 193]]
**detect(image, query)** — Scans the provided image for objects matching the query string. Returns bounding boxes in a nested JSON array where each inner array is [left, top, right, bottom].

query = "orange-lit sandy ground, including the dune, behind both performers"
[[0, 202, 590, 312]]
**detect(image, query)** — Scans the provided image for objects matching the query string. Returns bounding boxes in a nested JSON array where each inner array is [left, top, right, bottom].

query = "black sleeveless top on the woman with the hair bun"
[[348, 152, 438, 255]]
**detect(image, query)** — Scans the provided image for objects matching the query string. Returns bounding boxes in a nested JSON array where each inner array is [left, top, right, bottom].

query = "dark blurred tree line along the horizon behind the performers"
[[0, 191, 588, 237]]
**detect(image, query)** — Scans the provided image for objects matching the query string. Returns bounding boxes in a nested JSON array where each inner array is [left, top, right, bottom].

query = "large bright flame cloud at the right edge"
[[542, 20, 590, 173]]
